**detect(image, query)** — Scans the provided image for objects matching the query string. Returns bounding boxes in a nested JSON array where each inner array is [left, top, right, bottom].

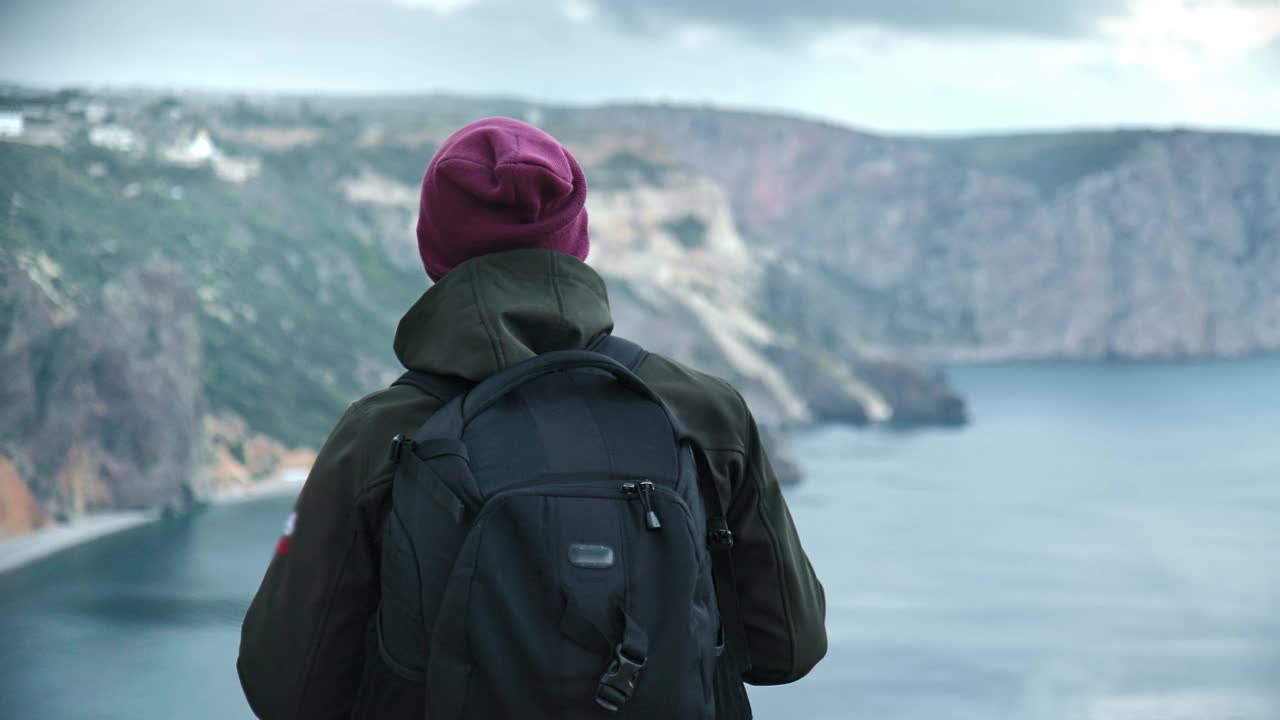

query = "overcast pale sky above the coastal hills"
[[0, 0, 1280, 133]]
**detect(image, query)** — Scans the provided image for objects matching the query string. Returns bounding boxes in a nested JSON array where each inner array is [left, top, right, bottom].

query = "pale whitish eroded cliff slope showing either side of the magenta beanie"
[[322, 122, 964, 424]]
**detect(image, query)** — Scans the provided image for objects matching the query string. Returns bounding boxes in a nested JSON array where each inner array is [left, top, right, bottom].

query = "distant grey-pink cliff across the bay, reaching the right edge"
[[591, 108, 1280, 361]]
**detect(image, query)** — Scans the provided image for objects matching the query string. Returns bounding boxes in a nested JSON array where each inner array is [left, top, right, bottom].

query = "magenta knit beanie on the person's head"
[[417, 118, 590, 281]]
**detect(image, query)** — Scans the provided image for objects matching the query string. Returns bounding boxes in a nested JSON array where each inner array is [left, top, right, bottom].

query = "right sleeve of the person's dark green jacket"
[[721, 404, 827, 685]]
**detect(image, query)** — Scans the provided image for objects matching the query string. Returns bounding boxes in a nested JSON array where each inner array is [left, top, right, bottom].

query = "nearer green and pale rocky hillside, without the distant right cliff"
[[0, 92, 964, 528]]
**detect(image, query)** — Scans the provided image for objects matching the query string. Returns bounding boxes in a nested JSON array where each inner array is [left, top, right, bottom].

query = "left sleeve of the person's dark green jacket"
[[237, 406, 388, 720]]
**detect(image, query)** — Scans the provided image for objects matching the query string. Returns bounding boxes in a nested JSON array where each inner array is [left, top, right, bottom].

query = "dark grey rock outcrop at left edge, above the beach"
[[0, 254, 204, 524]]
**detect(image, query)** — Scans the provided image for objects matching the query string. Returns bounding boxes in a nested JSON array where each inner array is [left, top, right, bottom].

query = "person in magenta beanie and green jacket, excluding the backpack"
[[237, 118, 827, 720]]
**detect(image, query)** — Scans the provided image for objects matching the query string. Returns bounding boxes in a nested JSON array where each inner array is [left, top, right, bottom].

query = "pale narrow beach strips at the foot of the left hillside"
[[0, 474, 305, 575]]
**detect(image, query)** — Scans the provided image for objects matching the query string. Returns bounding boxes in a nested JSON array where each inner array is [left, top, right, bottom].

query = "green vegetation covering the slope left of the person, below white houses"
[[0, 134, 426, 446]]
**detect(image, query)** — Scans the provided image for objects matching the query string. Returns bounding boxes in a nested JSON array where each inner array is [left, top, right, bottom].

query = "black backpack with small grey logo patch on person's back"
[[355, 336, 750, 720]]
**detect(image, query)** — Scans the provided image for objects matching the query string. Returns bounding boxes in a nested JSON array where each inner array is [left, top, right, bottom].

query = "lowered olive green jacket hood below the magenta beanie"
[[396, 250, 613, 382]]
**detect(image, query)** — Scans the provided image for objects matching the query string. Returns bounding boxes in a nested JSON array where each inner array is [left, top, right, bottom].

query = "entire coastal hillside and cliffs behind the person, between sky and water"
[[0, 90, 1280, 527]]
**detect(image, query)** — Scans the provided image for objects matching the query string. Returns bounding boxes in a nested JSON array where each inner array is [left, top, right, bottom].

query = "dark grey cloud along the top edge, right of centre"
[[588, 0, 1131, 38]]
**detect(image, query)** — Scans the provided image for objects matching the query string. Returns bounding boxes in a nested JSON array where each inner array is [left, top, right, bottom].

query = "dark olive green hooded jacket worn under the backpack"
[[237, 250, 827, 720]]
